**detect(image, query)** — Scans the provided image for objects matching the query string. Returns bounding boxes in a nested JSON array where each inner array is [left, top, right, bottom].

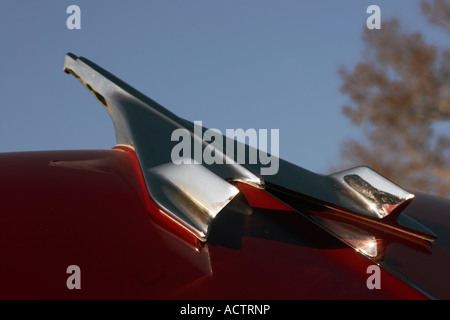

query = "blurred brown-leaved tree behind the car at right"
[[340, 0, 450, 198]]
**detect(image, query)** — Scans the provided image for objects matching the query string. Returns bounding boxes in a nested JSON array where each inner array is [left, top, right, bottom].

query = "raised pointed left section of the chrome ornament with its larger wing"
[[63, 53, 264, 241]]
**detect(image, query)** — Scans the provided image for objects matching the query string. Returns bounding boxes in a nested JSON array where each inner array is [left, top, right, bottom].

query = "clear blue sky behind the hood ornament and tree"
[[0, 0, 444, 173]]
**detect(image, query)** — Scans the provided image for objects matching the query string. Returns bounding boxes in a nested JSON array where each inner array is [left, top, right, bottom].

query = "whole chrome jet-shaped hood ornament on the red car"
[[63, 53, 436, 245]]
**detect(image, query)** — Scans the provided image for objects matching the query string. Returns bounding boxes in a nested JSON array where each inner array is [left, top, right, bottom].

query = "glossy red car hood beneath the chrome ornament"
[[0, 148, 426, 299]]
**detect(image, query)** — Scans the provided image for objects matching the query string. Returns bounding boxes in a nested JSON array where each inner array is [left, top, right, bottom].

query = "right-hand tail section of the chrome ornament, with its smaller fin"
[[262, 159, 437, 242]]
